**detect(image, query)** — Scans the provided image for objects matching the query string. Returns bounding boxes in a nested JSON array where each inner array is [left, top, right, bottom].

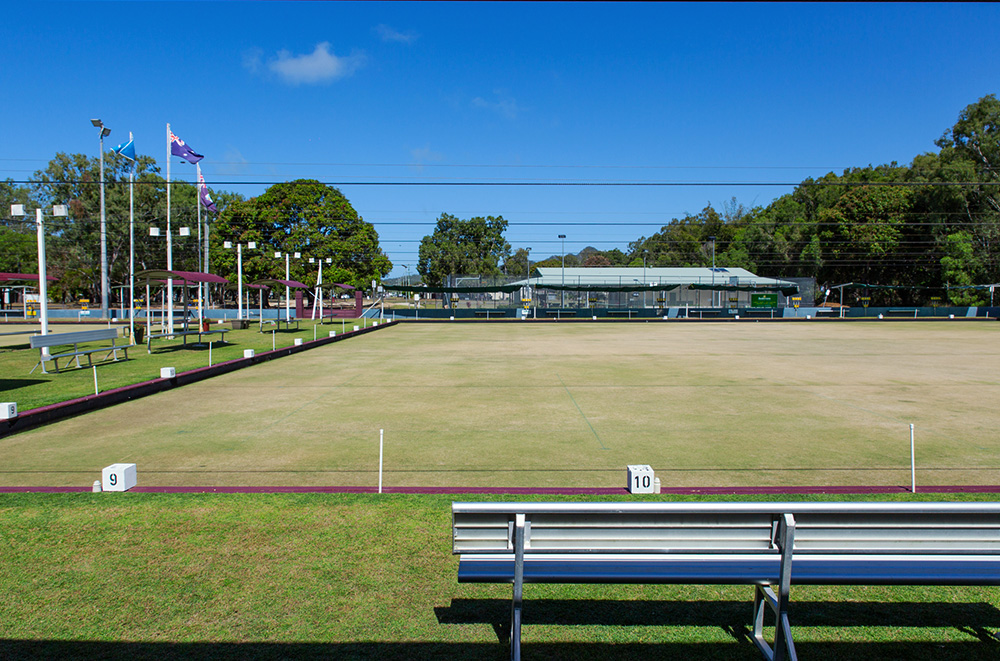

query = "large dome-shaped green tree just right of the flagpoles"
[[210, 179, 392, 289]]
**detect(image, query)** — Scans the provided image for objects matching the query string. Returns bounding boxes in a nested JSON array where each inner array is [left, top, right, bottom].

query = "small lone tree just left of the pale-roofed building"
[[417, 213, 510, 286]]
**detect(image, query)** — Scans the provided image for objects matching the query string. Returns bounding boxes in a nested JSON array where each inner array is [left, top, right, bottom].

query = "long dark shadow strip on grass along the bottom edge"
[[0, 640, 997, 661]]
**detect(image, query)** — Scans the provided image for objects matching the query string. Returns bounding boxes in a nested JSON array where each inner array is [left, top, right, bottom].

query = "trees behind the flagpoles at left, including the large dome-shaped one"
[[0, 151, 392, 302]]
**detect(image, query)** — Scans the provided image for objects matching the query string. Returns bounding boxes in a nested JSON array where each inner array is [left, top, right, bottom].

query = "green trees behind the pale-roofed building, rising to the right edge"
[[418, 94, 1000, 305]]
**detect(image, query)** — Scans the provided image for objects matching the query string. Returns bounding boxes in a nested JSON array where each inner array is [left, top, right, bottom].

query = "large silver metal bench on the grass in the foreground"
[[452, 502, 1000, 661]]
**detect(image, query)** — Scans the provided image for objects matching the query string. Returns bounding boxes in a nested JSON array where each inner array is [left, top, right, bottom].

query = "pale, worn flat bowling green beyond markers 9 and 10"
[[0, 321, 1000, 487]]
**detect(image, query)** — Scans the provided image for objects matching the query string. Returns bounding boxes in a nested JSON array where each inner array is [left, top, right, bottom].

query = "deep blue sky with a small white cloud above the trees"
[[0, 1, 1000, 276]]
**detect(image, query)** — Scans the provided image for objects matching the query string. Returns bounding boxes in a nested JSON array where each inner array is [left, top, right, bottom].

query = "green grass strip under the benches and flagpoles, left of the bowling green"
[[0, 319, 371, 411]]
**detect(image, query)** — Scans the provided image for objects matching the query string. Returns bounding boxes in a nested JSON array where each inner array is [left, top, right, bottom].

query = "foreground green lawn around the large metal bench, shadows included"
[[0, 493, 1000, 661]]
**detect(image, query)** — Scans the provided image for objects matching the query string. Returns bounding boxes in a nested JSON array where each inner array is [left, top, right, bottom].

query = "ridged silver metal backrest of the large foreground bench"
[[452, 502, 1000, 555]]
